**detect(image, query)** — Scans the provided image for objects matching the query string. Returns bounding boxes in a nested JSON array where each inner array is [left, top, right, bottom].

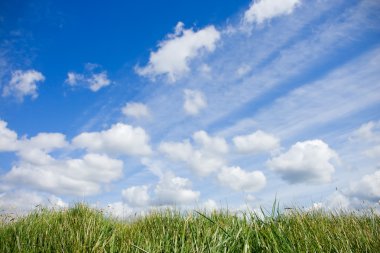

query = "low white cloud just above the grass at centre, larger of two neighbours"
[[154, 173, 200, 205]]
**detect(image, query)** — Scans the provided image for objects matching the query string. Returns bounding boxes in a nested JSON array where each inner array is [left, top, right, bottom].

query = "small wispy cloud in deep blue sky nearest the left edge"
[[3, 70, 45, 101]]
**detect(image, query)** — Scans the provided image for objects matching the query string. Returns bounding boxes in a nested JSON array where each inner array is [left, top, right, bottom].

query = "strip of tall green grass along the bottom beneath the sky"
[[0, 204, 380, 253]]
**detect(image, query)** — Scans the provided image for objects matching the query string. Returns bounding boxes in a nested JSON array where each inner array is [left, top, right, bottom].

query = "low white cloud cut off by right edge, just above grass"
[[350, 170, 380, 202]]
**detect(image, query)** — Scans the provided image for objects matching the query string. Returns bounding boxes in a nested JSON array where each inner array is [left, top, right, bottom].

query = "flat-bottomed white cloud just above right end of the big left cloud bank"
[[73, 123, 152, 155]]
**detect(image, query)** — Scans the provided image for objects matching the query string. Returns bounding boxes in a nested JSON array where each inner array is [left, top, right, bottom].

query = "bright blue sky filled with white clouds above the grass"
[[0, 0, 380, 218]]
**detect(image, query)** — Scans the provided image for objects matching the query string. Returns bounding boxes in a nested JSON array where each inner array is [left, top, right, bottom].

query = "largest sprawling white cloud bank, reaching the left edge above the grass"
[[0, 121, 123, 196]]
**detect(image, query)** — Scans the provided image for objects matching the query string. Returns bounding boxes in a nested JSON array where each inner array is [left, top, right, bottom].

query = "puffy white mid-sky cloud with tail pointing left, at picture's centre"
[[159, 131, 228, 176]]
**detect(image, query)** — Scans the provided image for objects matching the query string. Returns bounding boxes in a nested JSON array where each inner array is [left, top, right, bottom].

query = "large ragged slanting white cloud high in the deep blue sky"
[[136, 22, 221, 83]]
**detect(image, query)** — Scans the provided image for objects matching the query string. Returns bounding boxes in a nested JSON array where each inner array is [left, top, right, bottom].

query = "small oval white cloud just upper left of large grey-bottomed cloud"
[[233, 130, 280, 153]]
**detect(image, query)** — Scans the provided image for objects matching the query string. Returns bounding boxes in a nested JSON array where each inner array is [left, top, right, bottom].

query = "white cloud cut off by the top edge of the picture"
[[244, 0, 301, 24]]
